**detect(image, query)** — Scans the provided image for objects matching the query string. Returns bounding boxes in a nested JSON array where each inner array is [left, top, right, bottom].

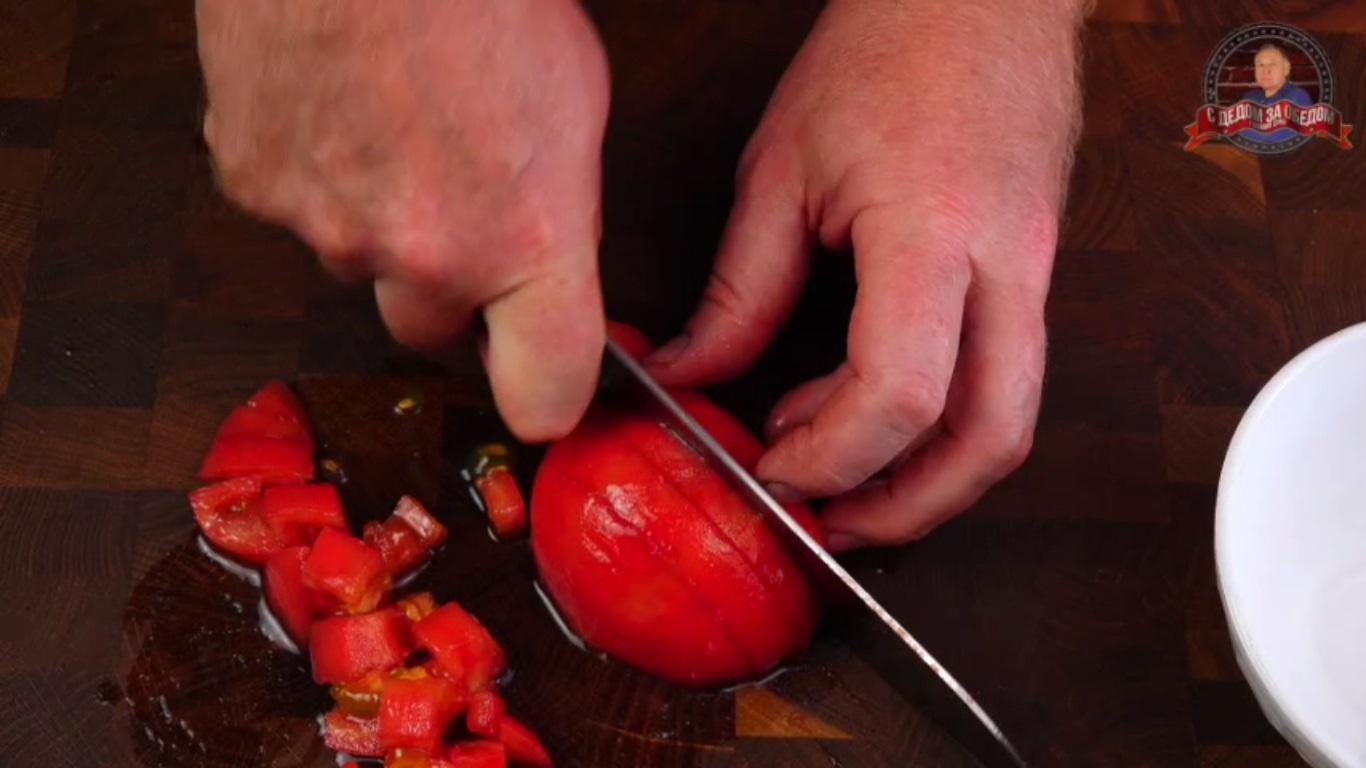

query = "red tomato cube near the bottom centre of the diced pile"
[[380, 670, 464, 753]]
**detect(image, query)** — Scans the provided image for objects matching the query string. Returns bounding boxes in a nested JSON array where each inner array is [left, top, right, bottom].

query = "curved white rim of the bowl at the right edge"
[[1214, 317, 1366, 768]]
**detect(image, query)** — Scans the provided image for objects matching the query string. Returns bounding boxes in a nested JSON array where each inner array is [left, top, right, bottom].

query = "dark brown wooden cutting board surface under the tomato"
[[0, 0, 1366, 768]]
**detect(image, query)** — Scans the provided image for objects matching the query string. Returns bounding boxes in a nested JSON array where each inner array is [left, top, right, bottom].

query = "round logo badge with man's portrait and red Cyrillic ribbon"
[[1186, 22, 1352, 154]]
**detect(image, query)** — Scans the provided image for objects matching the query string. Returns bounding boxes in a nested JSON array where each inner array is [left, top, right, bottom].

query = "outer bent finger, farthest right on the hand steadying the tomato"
[[822, 271, 1045, 549]]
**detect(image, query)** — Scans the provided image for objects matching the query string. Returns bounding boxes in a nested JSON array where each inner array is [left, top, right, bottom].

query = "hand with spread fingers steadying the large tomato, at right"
[[649, 0, 1082, 549]]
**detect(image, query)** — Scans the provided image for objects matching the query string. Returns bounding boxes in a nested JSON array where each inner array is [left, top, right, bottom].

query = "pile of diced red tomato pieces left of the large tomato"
[[189, 381, 549, 768]]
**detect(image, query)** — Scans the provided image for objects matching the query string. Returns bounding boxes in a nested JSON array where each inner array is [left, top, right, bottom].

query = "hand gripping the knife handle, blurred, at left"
[[197, 0, 609, 440]]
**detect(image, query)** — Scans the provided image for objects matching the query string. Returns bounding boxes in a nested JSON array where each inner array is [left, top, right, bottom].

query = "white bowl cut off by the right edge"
[[1214, 324, 1366, 768]]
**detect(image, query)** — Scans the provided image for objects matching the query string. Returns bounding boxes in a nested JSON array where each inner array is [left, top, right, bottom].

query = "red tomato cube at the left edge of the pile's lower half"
[[309, 607, 413, 685]]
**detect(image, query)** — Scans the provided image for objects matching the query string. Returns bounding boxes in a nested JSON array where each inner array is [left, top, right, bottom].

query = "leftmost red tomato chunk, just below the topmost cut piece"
[[190, 477, 306, 566]]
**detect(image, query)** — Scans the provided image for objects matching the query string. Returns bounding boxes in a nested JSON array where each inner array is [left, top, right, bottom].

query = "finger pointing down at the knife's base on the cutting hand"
[[484, 252, 607, 443]]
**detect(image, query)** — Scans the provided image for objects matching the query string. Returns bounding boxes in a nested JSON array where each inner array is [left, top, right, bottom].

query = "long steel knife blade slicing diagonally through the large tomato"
[[602, 339, 1025, 768]]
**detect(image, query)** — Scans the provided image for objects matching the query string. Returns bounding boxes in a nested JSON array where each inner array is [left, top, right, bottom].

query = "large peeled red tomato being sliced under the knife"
[[531, 382, 824, 686]]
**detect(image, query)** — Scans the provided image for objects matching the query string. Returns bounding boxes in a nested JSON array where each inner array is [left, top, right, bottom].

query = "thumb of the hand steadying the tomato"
[[646, 151, 809, 385]]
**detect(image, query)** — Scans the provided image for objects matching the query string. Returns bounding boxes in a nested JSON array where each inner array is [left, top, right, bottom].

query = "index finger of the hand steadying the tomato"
[[757, 206, 970, 496]]
